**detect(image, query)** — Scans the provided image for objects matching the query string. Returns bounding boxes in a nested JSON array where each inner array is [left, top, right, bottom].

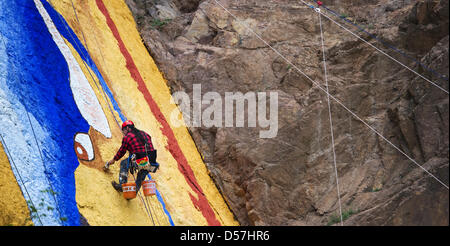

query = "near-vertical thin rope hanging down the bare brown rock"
[[316, 8, 344, 226]]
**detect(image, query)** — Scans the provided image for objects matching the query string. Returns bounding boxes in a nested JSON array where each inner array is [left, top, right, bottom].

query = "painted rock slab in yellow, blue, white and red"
[[0, 0, 238, 226]]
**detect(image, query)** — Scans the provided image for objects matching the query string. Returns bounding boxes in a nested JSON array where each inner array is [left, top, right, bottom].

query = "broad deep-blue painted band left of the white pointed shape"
[[0, 0, 89, 225]]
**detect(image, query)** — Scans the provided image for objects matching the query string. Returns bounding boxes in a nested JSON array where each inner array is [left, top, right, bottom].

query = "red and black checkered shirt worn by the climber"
[[114, 131, 154, 161]]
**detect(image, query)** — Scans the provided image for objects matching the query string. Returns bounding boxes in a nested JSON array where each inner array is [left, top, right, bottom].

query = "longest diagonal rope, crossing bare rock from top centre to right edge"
[[214, 0, 449, 190]]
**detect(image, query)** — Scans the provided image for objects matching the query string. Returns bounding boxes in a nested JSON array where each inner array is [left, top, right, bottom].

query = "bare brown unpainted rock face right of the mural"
[[126, 0, 449, 225]]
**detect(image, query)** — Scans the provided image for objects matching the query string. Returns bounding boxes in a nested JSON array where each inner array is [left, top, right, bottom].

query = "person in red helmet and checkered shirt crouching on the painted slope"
[[103, 120, 159, 192]]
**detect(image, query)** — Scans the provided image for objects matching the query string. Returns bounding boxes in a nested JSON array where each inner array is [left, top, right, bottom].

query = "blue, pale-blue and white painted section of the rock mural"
[[0, 1, 118, 225]]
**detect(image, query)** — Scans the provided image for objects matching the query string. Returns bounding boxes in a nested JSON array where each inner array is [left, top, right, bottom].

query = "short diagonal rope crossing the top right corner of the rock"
[[313, 0, 448, 82]]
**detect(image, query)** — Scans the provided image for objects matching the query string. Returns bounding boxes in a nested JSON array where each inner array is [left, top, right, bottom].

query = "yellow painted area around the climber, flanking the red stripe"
[[51, 0, 237, 225]]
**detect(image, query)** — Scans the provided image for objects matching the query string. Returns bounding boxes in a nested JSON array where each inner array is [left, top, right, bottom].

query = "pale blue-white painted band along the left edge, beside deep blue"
[[0, 87, 61, 226]]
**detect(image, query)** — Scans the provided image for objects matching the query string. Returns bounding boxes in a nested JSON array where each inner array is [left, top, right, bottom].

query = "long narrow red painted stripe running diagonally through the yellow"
[[96, 0, 220, 226]]
